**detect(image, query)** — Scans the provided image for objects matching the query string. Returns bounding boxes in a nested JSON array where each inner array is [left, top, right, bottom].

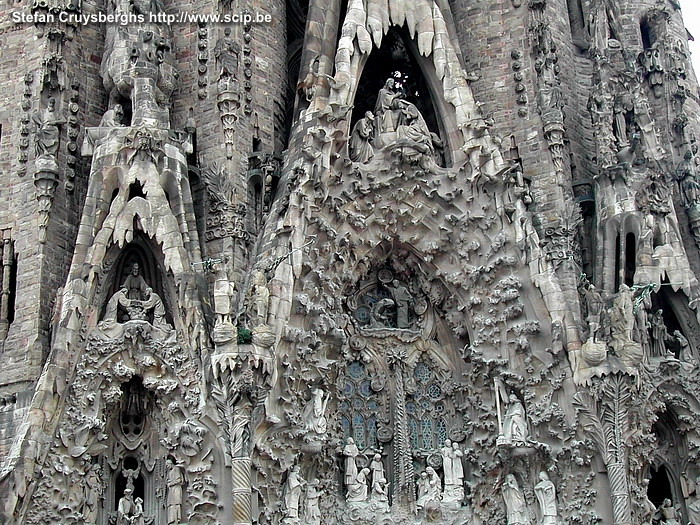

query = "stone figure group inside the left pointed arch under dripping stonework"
[[97, 263, 174, 339]]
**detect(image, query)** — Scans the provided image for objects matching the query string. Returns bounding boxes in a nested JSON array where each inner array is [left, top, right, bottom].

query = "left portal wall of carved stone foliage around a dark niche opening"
[[27, 321, 222, 524]]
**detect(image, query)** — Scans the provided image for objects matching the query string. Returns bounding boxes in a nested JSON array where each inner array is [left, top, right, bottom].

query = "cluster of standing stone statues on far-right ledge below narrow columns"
[[580, 283, 695, 367]]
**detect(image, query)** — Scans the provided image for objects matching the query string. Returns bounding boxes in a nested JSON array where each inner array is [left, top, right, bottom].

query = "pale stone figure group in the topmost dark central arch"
[[349, 78, 440, 164]]
